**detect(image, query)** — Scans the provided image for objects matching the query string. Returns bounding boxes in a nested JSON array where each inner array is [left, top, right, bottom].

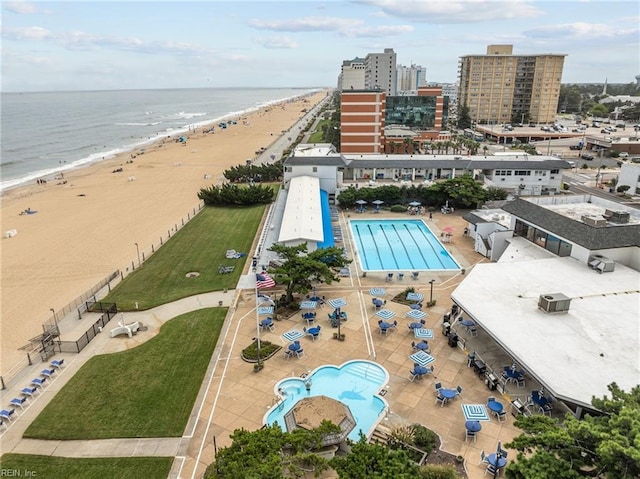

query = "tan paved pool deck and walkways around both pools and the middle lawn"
[[0, 212, 531, 479]]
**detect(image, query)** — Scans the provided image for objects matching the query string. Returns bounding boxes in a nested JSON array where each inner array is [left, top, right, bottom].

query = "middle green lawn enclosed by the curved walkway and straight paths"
[[24, 308, 227, 440]]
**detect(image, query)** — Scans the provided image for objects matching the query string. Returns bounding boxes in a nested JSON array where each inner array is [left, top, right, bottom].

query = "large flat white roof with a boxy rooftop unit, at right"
[[452, 255, 640, 406]]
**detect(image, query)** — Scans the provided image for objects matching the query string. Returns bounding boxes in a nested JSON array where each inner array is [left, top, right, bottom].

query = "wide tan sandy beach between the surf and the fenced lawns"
[[0, 91, 326, 375]]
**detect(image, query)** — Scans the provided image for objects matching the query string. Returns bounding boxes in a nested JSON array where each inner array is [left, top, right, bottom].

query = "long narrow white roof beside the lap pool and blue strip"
[[278, 176, 324, 242]]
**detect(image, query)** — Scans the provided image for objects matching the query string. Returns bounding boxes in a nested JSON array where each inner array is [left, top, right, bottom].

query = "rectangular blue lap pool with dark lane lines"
[[349, 220, 461, 271]]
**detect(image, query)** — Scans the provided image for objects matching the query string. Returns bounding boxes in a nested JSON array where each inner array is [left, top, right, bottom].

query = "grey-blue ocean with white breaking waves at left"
[[0, 88, 318, 191]]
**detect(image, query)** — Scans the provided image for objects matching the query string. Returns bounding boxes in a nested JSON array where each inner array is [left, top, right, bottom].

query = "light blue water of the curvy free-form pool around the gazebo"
[[263, 360, 389, 441]]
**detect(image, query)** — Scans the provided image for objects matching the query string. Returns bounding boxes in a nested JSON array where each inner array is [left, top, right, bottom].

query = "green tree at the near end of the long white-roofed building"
[[269, 243, 351, 304]]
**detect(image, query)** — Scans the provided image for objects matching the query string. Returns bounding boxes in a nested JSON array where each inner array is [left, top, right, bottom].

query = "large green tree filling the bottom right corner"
[[505, 383, 640, 479]]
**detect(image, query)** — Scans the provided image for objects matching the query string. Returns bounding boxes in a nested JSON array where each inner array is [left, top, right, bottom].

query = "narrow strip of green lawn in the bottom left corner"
[[0, 454, 173, 479]]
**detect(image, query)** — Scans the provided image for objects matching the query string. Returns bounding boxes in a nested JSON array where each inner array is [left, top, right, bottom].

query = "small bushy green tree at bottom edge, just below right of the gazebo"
[[329, 434, 419, 479]]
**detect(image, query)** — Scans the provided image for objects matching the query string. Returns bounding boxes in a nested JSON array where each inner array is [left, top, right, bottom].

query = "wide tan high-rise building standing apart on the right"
[[458, 45, 566, 124]]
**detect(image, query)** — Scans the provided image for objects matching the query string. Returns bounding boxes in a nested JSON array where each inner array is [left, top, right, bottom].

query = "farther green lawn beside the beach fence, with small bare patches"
[[103, 205, 265, 311]]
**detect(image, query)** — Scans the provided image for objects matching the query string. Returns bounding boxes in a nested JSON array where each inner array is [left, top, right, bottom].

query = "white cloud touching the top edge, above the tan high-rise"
[[357, 0, 543, 24]]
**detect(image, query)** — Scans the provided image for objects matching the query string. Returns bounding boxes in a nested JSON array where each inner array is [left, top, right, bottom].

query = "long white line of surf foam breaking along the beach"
[[0, 89, 324, 198]]
